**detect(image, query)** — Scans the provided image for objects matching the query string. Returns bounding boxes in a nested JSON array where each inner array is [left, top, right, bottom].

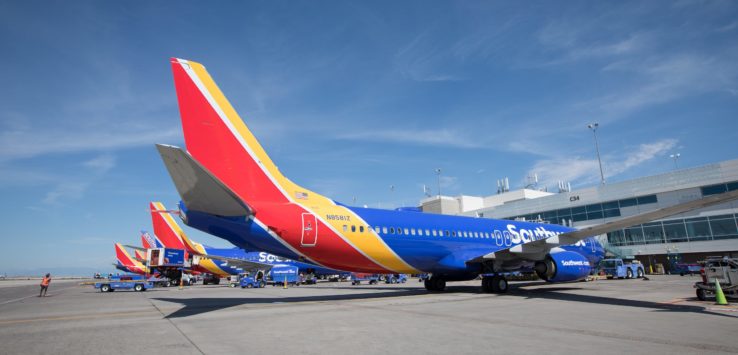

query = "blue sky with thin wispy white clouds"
[[0, 1, 738, 274]]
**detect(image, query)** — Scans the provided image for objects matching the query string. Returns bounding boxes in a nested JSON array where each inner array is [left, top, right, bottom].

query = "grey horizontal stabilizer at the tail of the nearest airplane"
[[156, 144, 253, 217]]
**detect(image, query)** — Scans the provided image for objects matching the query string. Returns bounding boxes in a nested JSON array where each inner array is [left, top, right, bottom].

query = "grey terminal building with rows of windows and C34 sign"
[[420, 160, 738, 271]]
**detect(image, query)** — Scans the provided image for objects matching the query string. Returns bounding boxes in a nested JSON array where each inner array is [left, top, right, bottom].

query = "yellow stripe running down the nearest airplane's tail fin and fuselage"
[[187, 61, 419, 273]]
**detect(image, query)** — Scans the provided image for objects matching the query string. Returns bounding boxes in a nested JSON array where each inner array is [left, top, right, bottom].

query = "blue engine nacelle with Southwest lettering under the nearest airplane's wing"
[[535, 251, 592, 282]]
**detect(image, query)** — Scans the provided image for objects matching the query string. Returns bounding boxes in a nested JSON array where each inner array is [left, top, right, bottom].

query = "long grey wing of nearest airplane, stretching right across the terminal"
[[478, 190, 738, 262]]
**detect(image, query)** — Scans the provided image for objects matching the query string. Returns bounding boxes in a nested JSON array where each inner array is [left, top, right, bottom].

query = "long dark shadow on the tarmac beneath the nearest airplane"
[[152, 282, 736, 318]]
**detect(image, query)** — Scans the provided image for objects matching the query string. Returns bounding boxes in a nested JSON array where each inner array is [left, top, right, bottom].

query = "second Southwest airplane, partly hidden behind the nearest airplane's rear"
[[149, 202, 342, 277]]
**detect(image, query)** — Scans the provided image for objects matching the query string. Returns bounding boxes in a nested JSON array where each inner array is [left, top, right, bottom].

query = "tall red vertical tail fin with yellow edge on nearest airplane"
[[172, 58, 315, 208]]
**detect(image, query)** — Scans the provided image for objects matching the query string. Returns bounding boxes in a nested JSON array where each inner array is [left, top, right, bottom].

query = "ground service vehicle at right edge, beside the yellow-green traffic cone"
[[694, 257, 738, 301]]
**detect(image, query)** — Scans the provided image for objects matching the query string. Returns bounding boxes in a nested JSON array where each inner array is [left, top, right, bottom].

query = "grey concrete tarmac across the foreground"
[[0, 276, 738, 355]]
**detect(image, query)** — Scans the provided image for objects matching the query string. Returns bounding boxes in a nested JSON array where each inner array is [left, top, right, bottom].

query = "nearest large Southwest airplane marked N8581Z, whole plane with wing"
[[157, 58, 738, 293]]
